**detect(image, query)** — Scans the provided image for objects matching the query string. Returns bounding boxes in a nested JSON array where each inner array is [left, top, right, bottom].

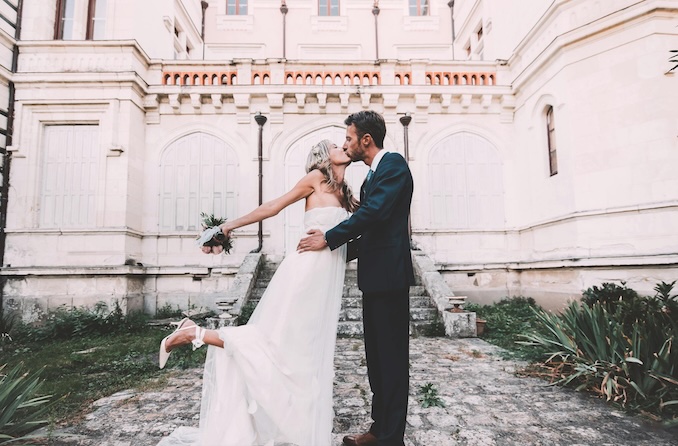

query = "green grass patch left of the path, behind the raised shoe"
[[0, 320, 207, 426]]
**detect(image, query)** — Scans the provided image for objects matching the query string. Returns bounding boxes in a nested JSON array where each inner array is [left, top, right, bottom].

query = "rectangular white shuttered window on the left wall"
[[40, 125, 101, 228]]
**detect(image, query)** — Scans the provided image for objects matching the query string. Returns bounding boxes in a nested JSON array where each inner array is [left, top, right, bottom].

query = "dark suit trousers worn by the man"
[[363, 287, 410, 446]]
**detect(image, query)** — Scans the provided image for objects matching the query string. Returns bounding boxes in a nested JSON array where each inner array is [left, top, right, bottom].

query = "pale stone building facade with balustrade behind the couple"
[[0, 0, 678, 319]]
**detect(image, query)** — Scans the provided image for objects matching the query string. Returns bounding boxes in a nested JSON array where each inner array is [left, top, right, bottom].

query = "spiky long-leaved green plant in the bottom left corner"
[[0, 364, 52, 444]]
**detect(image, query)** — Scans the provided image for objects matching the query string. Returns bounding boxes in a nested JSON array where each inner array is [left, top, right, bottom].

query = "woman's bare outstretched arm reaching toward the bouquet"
[[221, 170, 324, 236]]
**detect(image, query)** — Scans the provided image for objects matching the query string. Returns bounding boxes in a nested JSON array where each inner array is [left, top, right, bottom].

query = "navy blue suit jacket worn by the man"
[[325, 153, 414, 293]]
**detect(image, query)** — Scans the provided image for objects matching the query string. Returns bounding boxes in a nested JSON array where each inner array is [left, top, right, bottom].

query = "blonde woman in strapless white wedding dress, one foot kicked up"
[[160, 140, 358, 446]]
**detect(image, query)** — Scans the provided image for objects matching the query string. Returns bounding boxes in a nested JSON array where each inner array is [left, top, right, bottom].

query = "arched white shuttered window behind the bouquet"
[[159, 133, 237, 231]]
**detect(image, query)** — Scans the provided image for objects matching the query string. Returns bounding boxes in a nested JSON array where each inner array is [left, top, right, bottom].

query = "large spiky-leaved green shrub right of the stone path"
[[525, 282, 678, 420]]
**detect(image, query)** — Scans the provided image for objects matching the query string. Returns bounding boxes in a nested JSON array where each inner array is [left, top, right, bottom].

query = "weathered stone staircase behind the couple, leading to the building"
[[240, 259, 445, 338]]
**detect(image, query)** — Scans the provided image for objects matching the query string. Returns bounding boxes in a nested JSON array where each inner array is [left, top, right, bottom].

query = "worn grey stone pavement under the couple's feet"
[[50, 338, 678, 446]]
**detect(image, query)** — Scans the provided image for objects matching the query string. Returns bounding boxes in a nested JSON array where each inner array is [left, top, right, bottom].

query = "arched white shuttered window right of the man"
[[428, 132, 504, 229]]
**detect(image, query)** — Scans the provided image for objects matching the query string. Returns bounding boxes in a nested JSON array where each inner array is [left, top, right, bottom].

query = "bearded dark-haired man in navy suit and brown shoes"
[[298, 110, 414, 446]]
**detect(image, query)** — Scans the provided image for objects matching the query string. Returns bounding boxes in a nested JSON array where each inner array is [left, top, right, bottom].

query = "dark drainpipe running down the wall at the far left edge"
[[0, 0, 24, 314]]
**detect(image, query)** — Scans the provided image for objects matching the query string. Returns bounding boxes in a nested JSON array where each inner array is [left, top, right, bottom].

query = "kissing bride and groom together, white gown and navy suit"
[[160, 110, 414, 446]]
